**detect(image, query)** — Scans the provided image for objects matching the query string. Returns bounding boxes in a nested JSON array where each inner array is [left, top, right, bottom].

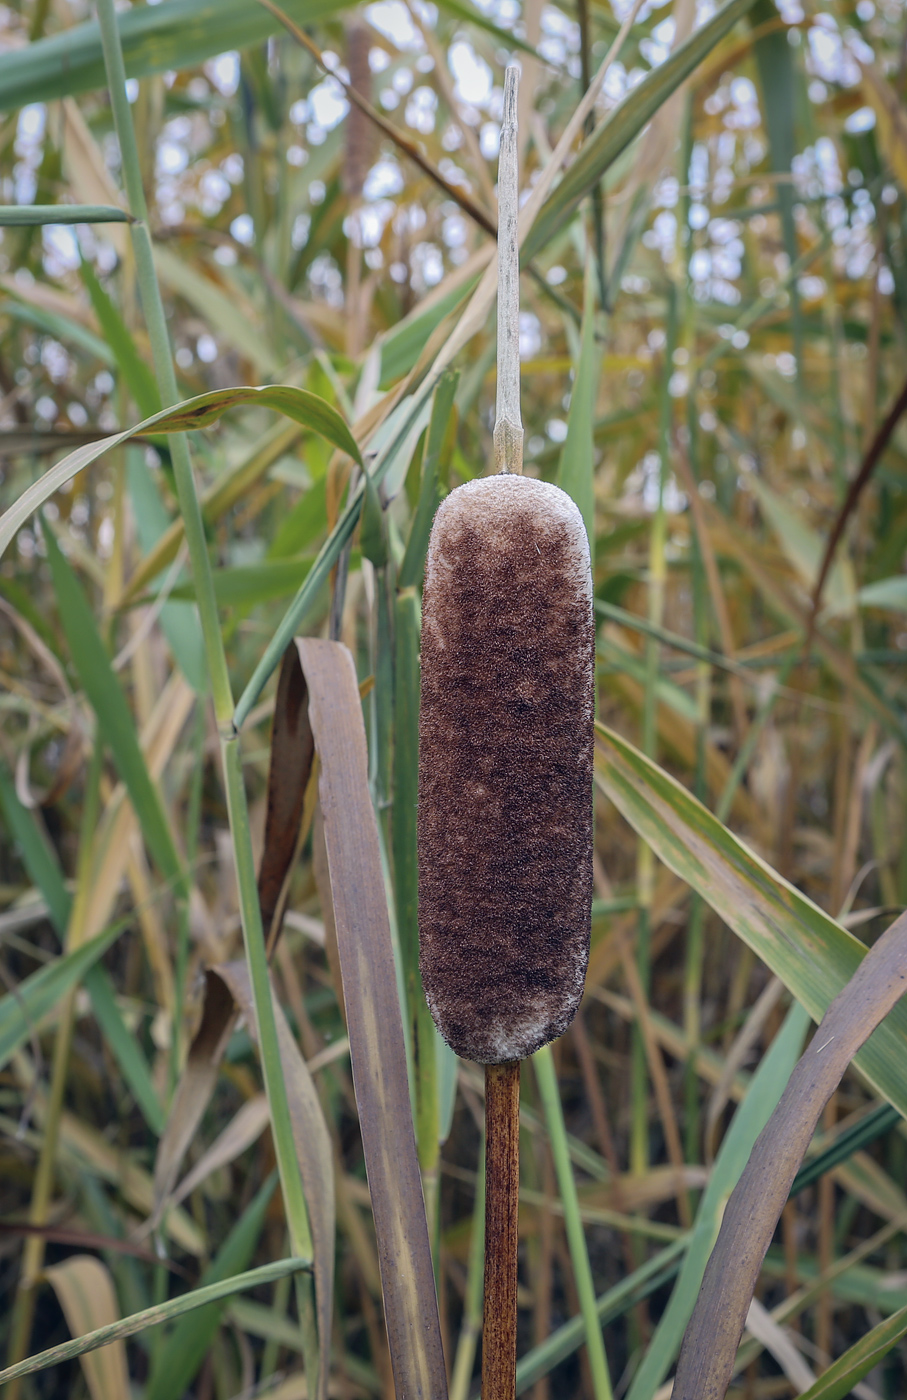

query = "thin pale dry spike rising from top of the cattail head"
[[494, 64, 522, 473]]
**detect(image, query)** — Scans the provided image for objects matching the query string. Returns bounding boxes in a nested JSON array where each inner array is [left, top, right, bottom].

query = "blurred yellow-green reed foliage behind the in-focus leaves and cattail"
[[0, 0, 907, 1400]]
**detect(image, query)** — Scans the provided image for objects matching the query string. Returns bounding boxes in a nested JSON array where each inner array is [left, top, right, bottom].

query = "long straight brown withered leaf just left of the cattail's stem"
[[297, 638, 448, 1400]]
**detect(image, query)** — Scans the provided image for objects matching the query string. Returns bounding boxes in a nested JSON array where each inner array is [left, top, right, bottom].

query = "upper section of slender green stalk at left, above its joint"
[[98, 0, 232, 727]]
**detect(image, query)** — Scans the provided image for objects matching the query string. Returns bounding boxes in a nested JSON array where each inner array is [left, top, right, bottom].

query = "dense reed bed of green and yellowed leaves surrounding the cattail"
[[0, 0, 907, 1400]]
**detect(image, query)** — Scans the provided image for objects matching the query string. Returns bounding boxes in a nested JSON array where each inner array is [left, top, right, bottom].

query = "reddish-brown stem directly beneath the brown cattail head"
[[481, 1060, 519, 1400]]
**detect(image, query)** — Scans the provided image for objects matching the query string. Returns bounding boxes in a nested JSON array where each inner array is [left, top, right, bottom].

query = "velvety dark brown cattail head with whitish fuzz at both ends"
[[419, 476, 595, 1064]]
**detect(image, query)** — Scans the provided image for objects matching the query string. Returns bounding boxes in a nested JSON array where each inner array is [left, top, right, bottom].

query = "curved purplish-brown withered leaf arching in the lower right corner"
[[673, 914, 907, 1400]]
